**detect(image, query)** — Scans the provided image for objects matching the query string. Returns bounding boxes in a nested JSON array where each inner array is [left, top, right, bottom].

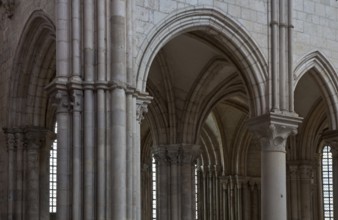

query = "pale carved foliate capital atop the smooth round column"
[[248, 112, 302, 152]]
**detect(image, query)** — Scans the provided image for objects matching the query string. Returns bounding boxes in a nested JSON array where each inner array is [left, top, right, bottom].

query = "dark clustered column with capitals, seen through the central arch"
[[154, 145, 199, 220]]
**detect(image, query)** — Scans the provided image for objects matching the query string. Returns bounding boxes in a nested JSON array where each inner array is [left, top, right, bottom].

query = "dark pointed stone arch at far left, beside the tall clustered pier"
[[7, 10, 55, 127]]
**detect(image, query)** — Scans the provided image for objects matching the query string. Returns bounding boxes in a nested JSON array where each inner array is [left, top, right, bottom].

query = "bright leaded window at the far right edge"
[[322, 146, 334, 220]]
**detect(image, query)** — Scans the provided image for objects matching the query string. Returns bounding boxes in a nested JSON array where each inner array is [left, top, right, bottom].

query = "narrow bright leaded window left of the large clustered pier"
[[49, 124, 57, 213]]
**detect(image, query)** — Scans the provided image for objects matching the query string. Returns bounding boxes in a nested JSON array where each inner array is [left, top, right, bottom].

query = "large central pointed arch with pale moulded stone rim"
[[136, 8, 267, 116]]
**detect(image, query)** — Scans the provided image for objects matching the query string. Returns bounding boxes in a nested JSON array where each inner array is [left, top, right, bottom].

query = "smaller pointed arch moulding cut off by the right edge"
[[293, 51, 338, 130]]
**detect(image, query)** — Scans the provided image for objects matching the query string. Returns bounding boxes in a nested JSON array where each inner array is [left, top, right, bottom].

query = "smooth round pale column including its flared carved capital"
[[249, 113, 301, 220]]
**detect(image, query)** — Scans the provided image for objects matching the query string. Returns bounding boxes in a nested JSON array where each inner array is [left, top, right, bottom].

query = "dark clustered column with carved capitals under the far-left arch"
[[4, 127, 55, 220]]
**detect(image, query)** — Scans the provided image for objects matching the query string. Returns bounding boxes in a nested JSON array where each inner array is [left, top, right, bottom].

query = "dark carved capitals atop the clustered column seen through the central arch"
[[153, 144, 200, 165]]
